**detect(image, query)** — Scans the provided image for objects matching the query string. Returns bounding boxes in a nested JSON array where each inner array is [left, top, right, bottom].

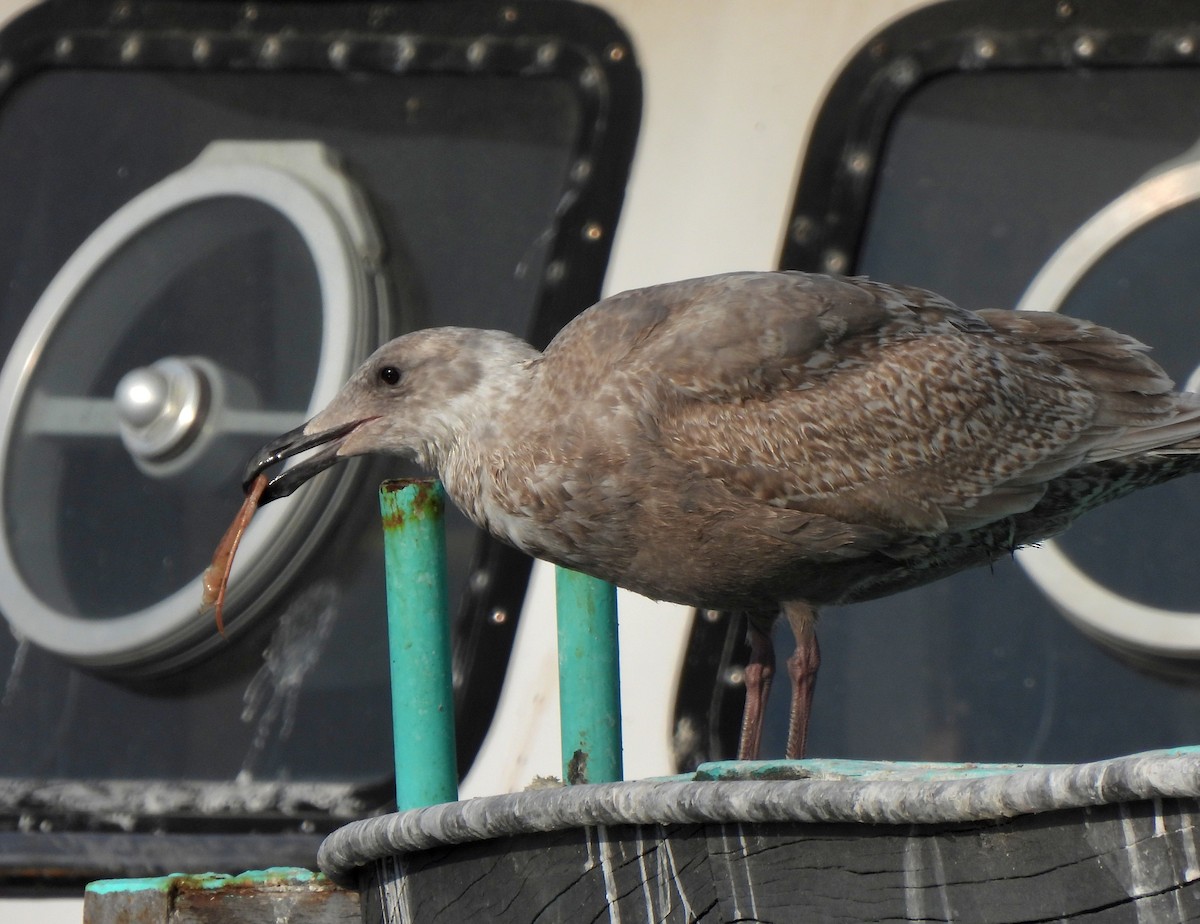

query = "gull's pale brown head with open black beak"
[[245, 328, 538, 504]]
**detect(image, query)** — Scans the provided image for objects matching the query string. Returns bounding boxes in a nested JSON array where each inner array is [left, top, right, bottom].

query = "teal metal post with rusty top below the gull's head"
[[379, 479, 458, 811]]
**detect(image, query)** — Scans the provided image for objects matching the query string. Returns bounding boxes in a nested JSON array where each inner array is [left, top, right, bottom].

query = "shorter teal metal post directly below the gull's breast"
[[556, 568, 623, 784]]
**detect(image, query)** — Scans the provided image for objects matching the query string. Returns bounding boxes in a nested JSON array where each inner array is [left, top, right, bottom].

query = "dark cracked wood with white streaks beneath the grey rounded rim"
[[364, 799, 1200, 924]]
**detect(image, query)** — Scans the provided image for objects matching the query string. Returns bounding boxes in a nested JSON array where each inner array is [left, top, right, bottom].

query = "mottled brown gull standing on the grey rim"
[[247, 272, 1200, 757]]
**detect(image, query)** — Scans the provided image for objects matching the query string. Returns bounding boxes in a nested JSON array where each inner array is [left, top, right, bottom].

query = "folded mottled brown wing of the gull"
[[546, 274, 1175, 534]]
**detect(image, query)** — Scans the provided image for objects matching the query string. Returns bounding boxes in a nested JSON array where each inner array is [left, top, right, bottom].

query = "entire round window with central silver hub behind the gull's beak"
[[0, 142, 386, 672]]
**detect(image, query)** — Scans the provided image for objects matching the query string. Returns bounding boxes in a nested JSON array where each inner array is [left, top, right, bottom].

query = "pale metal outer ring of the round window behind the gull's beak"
[[0, 142, 385, 667]]
